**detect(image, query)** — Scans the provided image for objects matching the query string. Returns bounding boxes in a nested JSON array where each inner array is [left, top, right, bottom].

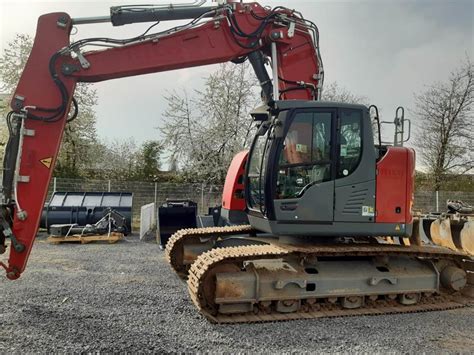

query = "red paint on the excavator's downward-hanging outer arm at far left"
[[7, 13, 76, 278]]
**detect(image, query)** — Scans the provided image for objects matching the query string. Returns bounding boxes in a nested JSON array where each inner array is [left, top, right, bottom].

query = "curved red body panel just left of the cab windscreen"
[[222, 151, 249, 211]]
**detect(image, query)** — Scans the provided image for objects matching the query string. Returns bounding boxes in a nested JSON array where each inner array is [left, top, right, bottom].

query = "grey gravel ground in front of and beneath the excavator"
[[0, 237, 474, 354]]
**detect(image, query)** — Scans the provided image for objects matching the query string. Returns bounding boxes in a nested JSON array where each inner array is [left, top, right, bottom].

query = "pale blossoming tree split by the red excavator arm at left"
[[0, 34, 97, 177]]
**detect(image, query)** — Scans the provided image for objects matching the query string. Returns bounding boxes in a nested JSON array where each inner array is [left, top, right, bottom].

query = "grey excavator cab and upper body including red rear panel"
[[245, 100, 414, 237]]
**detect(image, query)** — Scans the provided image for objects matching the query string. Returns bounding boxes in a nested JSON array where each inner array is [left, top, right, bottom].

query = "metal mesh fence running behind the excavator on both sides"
[[48, 178, 474, 228]]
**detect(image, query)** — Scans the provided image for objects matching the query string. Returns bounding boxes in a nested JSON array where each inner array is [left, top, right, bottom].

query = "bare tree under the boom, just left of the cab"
[[160, 63, 260, 184]]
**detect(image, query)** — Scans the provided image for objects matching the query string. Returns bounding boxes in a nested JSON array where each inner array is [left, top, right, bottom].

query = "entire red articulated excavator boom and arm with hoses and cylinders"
[[0, 2, 323, 279]]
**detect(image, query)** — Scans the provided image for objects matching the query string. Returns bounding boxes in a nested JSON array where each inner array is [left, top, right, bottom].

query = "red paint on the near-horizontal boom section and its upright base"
[[65, 3, 319, 100]]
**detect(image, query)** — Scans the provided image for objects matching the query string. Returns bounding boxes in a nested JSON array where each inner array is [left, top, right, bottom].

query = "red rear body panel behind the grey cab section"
[[375, 147, 415, 224]]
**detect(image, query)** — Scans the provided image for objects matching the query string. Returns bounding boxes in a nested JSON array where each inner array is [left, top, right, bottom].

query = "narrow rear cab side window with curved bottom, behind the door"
[[337, 110, 362, 178]]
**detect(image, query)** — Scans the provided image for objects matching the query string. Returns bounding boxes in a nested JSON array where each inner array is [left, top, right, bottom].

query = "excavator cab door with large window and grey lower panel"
[[273, 108, 336, 223]]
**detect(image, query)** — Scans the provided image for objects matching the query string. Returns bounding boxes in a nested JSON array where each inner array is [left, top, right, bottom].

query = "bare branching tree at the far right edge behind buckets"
[[415, 58, 474, 190]]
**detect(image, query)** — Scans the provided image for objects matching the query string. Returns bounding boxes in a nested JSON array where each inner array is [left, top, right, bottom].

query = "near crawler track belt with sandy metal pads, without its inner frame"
[[188, 244, 472, 323]]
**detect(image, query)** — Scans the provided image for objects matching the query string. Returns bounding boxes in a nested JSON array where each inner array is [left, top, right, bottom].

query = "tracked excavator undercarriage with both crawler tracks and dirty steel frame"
[[166, 226, 474, 323]]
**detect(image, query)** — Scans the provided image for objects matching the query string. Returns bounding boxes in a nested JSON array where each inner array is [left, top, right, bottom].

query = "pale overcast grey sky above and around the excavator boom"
[[0, 0, 474, 147]]
